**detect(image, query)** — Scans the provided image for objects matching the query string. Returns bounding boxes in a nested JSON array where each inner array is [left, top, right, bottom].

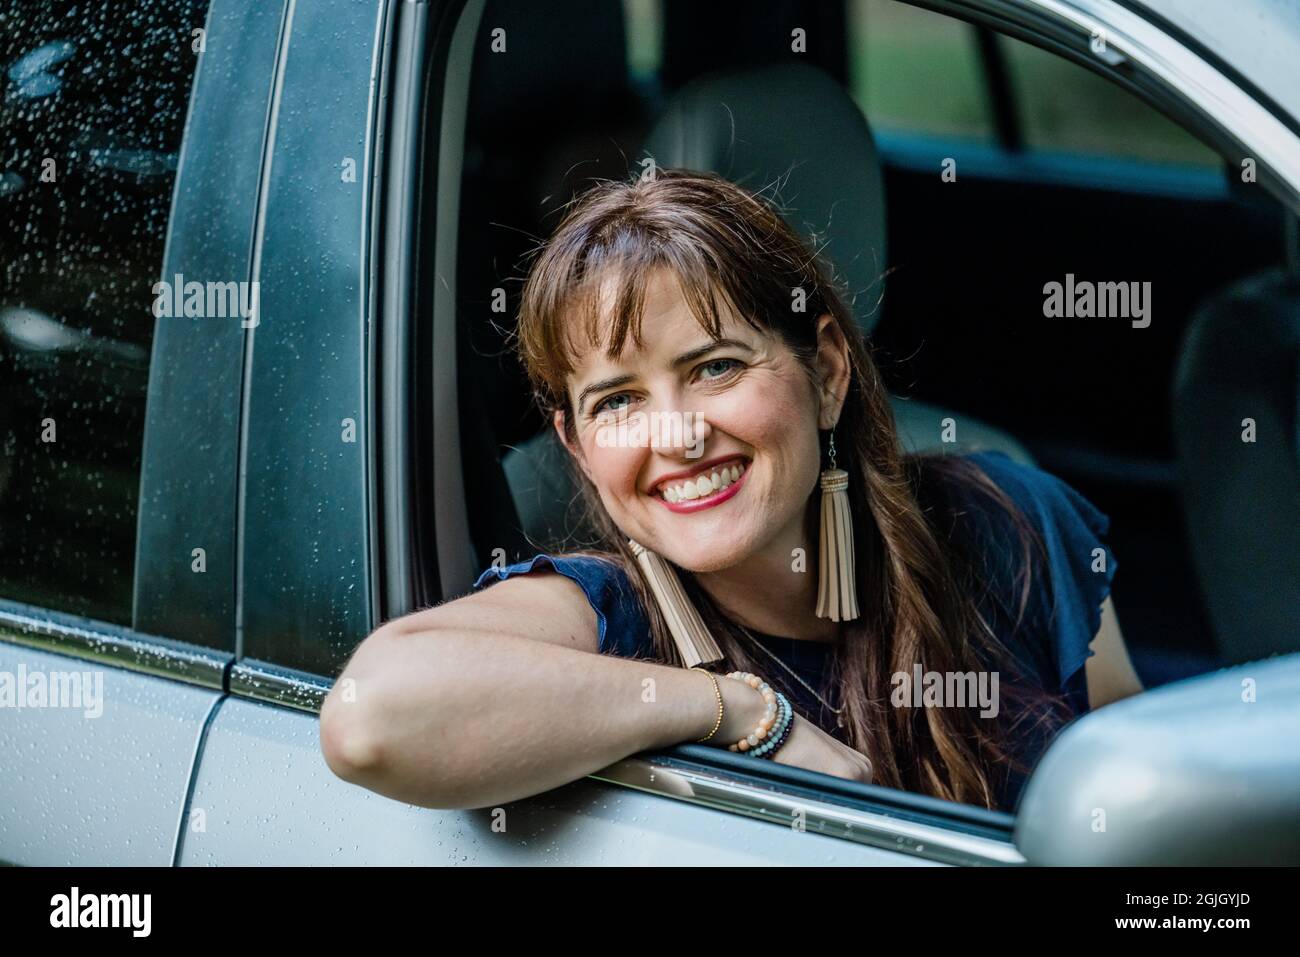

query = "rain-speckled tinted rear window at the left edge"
[[0, 0, 207, 624]]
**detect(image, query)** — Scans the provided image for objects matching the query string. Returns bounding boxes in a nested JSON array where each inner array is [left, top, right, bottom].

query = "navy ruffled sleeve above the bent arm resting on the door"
[[473, 553, 654, 658]]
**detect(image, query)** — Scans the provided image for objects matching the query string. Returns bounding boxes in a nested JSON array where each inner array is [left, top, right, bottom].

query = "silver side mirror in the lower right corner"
[[1015, 654, 1300, 866]]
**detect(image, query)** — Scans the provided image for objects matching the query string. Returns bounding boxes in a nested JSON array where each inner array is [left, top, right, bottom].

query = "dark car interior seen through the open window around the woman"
[[456, 0, 1300, 688]]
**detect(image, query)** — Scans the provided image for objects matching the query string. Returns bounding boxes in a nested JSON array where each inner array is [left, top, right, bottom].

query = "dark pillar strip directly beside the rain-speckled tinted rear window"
[[134, 0, 283, 654]]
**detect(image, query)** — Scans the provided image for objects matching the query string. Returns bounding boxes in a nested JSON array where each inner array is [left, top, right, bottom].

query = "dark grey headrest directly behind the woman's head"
[[644, 61, 885, 334]]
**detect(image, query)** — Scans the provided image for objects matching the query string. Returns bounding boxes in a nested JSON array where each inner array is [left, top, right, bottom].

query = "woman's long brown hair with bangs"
[[517, 168, 1069, 807]]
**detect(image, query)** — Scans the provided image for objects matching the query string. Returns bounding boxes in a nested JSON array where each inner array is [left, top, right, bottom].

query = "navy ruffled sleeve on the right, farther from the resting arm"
[[971, 451, 1118, 714]]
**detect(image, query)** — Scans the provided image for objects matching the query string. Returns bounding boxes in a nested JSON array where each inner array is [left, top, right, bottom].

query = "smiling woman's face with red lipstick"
[[555, 269, 846, 572]]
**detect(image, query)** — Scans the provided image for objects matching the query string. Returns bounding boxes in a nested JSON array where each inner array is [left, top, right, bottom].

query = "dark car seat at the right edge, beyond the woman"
[[1173, 261, 1300, 664]]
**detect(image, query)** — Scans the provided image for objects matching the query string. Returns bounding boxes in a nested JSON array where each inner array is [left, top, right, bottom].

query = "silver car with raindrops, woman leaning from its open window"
[[0, 0, 1300, 865]]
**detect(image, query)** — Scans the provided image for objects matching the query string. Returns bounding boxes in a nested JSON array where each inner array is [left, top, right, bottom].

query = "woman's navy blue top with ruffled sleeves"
[[475, 451, 1115, 810]]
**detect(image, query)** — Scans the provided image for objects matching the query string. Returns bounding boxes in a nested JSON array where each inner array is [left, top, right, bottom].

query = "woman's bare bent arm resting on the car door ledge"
[[320, 571, 764, 807]]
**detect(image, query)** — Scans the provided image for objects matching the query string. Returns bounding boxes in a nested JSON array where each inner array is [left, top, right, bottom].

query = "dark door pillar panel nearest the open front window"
[[231, 0, 387, 681]]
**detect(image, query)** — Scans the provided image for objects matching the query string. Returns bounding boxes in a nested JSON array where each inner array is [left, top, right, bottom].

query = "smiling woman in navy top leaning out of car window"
[[321, 169, 1141, 810]]
